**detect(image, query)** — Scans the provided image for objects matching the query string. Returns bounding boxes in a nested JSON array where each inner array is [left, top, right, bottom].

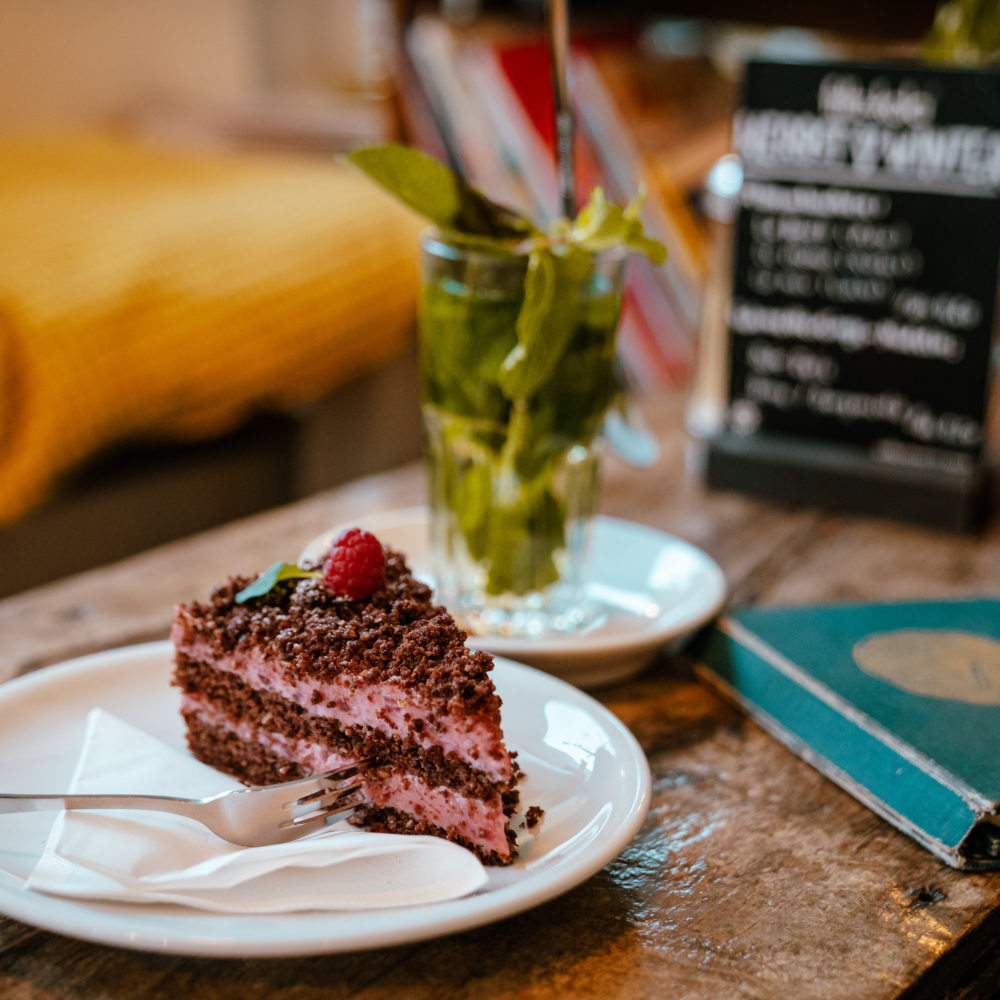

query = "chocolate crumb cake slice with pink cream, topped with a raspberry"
[[171, 529, 519, 865]]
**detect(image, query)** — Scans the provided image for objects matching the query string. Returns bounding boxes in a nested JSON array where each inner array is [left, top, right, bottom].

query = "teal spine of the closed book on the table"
[[696, 620, 1000, 868]]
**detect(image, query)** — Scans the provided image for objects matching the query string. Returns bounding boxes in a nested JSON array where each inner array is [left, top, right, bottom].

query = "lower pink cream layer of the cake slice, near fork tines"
[[187, 694, 510, 858]]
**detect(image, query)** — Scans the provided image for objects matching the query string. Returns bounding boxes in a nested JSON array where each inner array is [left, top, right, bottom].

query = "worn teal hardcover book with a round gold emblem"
[[691, 598, 1000, 869]]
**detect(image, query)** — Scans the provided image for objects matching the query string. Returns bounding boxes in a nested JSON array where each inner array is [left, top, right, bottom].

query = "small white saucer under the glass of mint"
[[299, 507, 726, 687]]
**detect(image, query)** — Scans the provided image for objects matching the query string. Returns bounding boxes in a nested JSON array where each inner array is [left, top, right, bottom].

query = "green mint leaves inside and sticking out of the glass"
[[348, 143, 666, 594]]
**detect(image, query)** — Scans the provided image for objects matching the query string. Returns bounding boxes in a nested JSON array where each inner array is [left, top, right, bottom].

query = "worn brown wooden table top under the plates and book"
[[0, 401, 1000, 1000]]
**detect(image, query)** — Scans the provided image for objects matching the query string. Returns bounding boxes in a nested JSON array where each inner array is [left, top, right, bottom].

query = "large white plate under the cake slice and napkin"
[[0, 642, 650, 958]]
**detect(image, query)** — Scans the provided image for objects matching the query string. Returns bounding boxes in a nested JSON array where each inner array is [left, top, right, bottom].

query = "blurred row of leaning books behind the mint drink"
[[390, 14, 735, 389]]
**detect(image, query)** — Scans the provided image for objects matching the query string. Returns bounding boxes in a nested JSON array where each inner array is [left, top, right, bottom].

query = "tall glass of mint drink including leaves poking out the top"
[[349, 144, 664, 636]]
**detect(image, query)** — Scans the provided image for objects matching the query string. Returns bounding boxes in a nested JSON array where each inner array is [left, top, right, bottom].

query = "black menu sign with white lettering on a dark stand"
[[708, 62, 1000, 527]]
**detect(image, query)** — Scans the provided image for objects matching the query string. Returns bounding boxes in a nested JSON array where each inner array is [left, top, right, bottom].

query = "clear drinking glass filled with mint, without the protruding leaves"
[[420, 231, 625, 637]]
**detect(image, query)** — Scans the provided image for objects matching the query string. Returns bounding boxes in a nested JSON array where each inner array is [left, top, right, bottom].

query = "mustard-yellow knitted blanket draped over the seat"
[[0, 137, 421, 523]]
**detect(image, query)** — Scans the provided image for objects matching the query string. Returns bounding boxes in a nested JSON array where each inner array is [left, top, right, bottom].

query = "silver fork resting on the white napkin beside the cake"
[[0, 761, 367, 847]]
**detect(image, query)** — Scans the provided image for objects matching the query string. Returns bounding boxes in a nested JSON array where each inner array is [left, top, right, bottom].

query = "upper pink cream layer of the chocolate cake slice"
[[171, 623, 512, 781]]
